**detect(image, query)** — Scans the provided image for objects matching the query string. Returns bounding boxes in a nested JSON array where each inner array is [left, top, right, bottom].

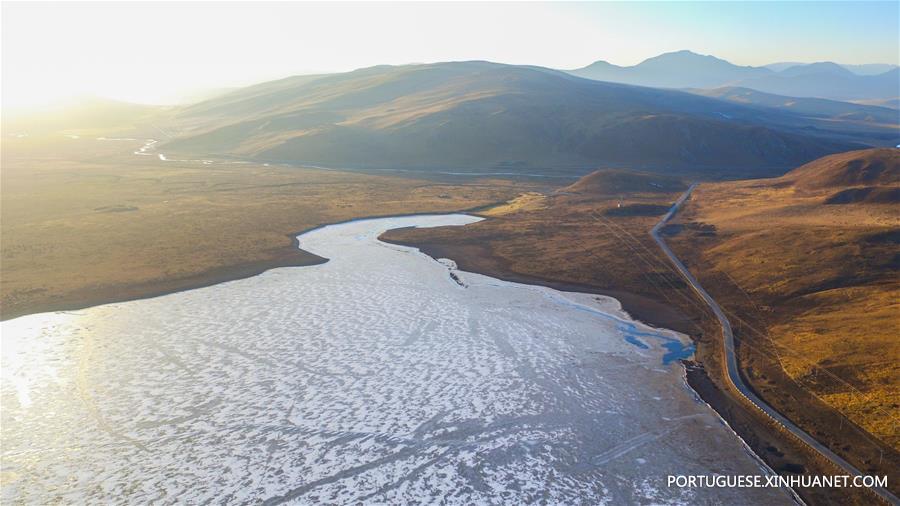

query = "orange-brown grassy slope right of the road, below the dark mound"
[[670, 180, 900, 449]]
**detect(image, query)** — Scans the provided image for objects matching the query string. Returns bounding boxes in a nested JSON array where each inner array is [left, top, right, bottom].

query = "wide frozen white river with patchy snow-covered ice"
[[0, 215, 790, 504]]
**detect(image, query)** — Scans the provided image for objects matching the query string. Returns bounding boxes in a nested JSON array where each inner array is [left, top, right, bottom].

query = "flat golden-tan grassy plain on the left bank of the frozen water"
[[0, 136, 531, 319]]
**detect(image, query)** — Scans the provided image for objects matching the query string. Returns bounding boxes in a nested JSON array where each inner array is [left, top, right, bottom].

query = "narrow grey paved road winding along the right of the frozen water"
[[650, 184, 900, 505]]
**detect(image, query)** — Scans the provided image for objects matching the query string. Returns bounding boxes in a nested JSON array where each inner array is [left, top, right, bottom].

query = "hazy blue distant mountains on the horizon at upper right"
[[569, 51, 900, 100]]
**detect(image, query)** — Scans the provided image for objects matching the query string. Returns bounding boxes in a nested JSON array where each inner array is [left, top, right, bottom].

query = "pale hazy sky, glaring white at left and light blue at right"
[[2, 1, 900, 108]]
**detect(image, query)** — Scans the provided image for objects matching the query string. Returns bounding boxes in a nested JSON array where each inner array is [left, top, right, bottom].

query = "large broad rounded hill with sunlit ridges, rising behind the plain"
[[164, 62, 859, 174]]
